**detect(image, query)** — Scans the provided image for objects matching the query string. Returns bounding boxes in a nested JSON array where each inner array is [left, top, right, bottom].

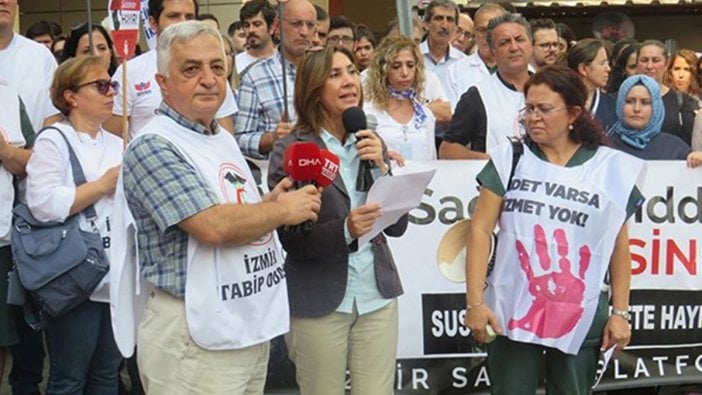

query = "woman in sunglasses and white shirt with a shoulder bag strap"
[[26, 56, 122, 394]]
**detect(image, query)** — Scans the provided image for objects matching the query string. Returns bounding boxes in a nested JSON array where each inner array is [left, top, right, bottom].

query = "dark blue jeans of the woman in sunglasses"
[[46, 301, 122, 395]]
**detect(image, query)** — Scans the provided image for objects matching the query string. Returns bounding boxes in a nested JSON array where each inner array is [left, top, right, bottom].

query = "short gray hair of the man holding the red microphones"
[[156, 20, 226, 77]]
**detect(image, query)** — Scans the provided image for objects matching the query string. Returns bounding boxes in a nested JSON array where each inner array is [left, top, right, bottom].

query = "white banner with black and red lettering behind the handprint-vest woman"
[[389, 161, 702, 393]]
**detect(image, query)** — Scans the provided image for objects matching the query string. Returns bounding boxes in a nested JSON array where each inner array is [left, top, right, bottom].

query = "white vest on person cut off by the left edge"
[[0, 84, 27, 246]]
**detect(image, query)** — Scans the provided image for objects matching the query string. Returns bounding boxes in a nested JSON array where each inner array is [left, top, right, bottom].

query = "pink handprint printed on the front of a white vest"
[[508, 225, 591, 338]]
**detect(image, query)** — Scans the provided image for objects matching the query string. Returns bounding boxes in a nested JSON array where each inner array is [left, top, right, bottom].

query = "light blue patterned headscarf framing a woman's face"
[[611, 74, 665, 149]]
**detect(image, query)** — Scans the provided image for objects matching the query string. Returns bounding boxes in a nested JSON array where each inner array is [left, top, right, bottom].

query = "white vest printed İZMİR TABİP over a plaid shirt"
[[142, 116, 290, 350]]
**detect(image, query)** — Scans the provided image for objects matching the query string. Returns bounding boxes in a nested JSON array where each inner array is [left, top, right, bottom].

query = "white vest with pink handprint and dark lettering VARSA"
[[485, 144, 643, 354]]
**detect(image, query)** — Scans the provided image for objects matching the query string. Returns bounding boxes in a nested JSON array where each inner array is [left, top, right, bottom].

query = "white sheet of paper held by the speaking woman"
[[358, 170, 436, 247]]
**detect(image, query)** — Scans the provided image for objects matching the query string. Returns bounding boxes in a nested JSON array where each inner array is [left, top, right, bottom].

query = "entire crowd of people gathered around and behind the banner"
[[0, 0, 702, 395]]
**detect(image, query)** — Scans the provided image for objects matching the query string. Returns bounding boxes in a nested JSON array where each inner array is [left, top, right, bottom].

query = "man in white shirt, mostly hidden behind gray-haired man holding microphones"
[[103, 0, 238, 139]]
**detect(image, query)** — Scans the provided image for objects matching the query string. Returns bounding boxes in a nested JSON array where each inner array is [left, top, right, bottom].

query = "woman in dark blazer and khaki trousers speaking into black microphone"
[[268, 48, 407, 395]]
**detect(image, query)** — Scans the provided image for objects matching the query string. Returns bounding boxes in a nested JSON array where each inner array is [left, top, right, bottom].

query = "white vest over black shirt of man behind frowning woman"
[[476, 73, 524, 152]]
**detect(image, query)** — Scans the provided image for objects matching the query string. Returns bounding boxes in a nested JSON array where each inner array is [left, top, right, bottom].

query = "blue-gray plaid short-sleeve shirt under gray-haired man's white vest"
[[122, 103, 218, 299]]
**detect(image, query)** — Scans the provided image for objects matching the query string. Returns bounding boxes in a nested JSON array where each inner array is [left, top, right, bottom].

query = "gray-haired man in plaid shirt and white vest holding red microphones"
[[119, 21, 321, 394]]
